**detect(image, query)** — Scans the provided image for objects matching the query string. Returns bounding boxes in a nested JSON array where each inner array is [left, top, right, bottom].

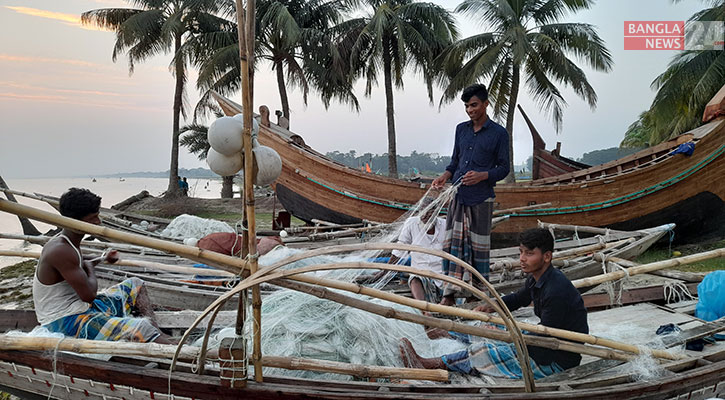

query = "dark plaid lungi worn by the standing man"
[[443, 198, 493, 296]]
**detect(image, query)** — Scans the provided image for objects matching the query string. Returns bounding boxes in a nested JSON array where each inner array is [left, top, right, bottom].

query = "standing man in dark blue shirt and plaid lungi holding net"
[[431, 84, 509, 305]]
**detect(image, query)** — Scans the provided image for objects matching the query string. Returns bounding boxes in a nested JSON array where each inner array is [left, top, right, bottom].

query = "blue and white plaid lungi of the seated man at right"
[[441, 342, 564, 379]]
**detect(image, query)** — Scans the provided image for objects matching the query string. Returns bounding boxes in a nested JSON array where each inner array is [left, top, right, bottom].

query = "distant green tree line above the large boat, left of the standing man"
[[326, 150, 451, 176]]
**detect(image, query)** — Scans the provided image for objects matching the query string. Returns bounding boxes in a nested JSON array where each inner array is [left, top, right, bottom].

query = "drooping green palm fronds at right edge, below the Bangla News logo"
[[621, 0, 725, 147]]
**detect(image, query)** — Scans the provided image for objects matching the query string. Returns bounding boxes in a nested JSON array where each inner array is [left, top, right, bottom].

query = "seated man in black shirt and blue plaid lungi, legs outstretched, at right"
[[400, 229, 589, 378]]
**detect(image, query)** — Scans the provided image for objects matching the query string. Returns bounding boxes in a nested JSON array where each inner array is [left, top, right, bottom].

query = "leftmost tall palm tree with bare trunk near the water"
[[81, 0, 218, 196]]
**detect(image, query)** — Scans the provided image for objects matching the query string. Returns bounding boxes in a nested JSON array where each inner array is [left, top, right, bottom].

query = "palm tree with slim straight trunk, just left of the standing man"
[[340, 0, 458, 177]]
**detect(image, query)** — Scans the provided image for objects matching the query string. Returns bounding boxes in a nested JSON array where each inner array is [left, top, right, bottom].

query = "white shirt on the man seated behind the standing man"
[[393, 217, 446, 287]]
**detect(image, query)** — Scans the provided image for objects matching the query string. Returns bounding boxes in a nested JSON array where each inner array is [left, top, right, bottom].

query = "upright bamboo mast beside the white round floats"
[[236, 0, 262, 382]]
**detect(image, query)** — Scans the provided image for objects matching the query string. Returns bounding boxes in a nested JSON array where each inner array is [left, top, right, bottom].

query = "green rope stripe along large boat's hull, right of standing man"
[[509, 145, 725, 217]]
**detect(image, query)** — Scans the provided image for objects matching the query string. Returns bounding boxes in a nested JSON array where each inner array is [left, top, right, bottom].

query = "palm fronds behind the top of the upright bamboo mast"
[[185, 0, 359, 124]]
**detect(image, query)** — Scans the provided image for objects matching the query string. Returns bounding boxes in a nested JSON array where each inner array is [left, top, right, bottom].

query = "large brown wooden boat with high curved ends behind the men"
[[209, 84, 725, 244]]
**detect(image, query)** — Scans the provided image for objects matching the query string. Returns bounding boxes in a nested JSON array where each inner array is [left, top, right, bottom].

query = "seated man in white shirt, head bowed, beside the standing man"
[[390, 197, 446, 303]]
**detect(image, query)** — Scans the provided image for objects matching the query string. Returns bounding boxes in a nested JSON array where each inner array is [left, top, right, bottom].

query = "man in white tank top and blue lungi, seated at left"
[[33, 188, 171, 343]]
